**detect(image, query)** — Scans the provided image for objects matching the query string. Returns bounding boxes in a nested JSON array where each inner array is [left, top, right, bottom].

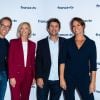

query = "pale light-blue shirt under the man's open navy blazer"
[[48, 38, 59, 80]]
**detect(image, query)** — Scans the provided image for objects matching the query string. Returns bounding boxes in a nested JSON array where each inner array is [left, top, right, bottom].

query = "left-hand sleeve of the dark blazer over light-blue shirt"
[[36, 42, 43, 79]]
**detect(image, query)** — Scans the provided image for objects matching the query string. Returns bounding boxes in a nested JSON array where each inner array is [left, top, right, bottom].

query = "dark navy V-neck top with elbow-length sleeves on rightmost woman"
[[60, 36, 97, 77]]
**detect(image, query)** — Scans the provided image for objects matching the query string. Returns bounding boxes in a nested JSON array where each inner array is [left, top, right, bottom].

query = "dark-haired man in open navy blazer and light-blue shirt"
[[36, 18, 66, 100]]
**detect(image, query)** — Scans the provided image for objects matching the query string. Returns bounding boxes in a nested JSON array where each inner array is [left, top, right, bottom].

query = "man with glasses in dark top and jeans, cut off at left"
[[0, 17, 12, 100]]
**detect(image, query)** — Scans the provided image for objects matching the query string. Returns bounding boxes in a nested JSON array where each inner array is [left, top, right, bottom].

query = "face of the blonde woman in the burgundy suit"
[[20, 24, 30, 38]]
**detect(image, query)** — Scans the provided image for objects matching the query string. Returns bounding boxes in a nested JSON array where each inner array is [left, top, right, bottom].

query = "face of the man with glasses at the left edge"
[[0, 19, 11, 37]]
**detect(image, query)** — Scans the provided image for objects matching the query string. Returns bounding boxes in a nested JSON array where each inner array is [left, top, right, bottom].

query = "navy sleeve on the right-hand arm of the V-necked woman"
[[90, 42, 97, 71]]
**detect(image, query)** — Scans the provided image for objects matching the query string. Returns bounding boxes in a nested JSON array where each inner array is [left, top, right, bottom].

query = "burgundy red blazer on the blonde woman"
[[8, 38, 36, 78]]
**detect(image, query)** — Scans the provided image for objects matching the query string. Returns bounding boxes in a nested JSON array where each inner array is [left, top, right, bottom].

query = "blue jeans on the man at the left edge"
[[0, 71, 7, 100]]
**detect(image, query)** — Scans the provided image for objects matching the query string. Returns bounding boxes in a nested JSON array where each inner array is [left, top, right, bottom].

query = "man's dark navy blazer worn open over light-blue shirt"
[[36, 37, 66, 81]]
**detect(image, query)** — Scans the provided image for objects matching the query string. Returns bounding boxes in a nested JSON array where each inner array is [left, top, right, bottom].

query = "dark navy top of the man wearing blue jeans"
[[0, 38, 9, 72]]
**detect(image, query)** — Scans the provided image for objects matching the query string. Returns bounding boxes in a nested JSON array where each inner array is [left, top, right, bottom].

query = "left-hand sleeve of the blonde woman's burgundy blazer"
[[8, 40, 15, 78]]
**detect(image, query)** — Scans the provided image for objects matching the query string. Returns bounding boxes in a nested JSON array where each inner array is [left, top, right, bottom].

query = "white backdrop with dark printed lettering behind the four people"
[[0, 0, 100, 100]]
